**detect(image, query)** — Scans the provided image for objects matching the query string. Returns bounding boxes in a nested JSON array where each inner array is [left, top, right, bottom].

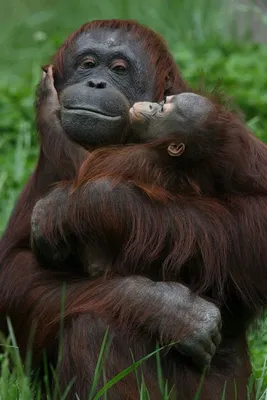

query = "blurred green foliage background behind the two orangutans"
[[0, 0, 267, 398]]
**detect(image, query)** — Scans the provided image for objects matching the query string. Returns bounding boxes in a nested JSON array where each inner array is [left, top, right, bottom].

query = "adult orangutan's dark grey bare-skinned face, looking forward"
[[55, 29, 157, 147]]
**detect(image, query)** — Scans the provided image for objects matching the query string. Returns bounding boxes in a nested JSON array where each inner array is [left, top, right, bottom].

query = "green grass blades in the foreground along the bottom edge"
[[0, 320, 267, 400]]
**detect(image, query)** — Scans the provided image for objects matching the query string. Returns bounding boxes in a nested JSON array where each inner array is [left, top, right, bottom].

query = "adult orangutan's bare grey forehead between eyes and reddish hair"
[[71, 28, 148, 63]]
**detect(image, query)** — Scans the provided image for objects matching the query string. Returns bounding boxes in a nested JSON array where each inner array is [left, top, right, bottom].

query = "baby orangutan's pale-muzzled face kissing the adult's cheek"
[[130, 93, 213, 156]]
